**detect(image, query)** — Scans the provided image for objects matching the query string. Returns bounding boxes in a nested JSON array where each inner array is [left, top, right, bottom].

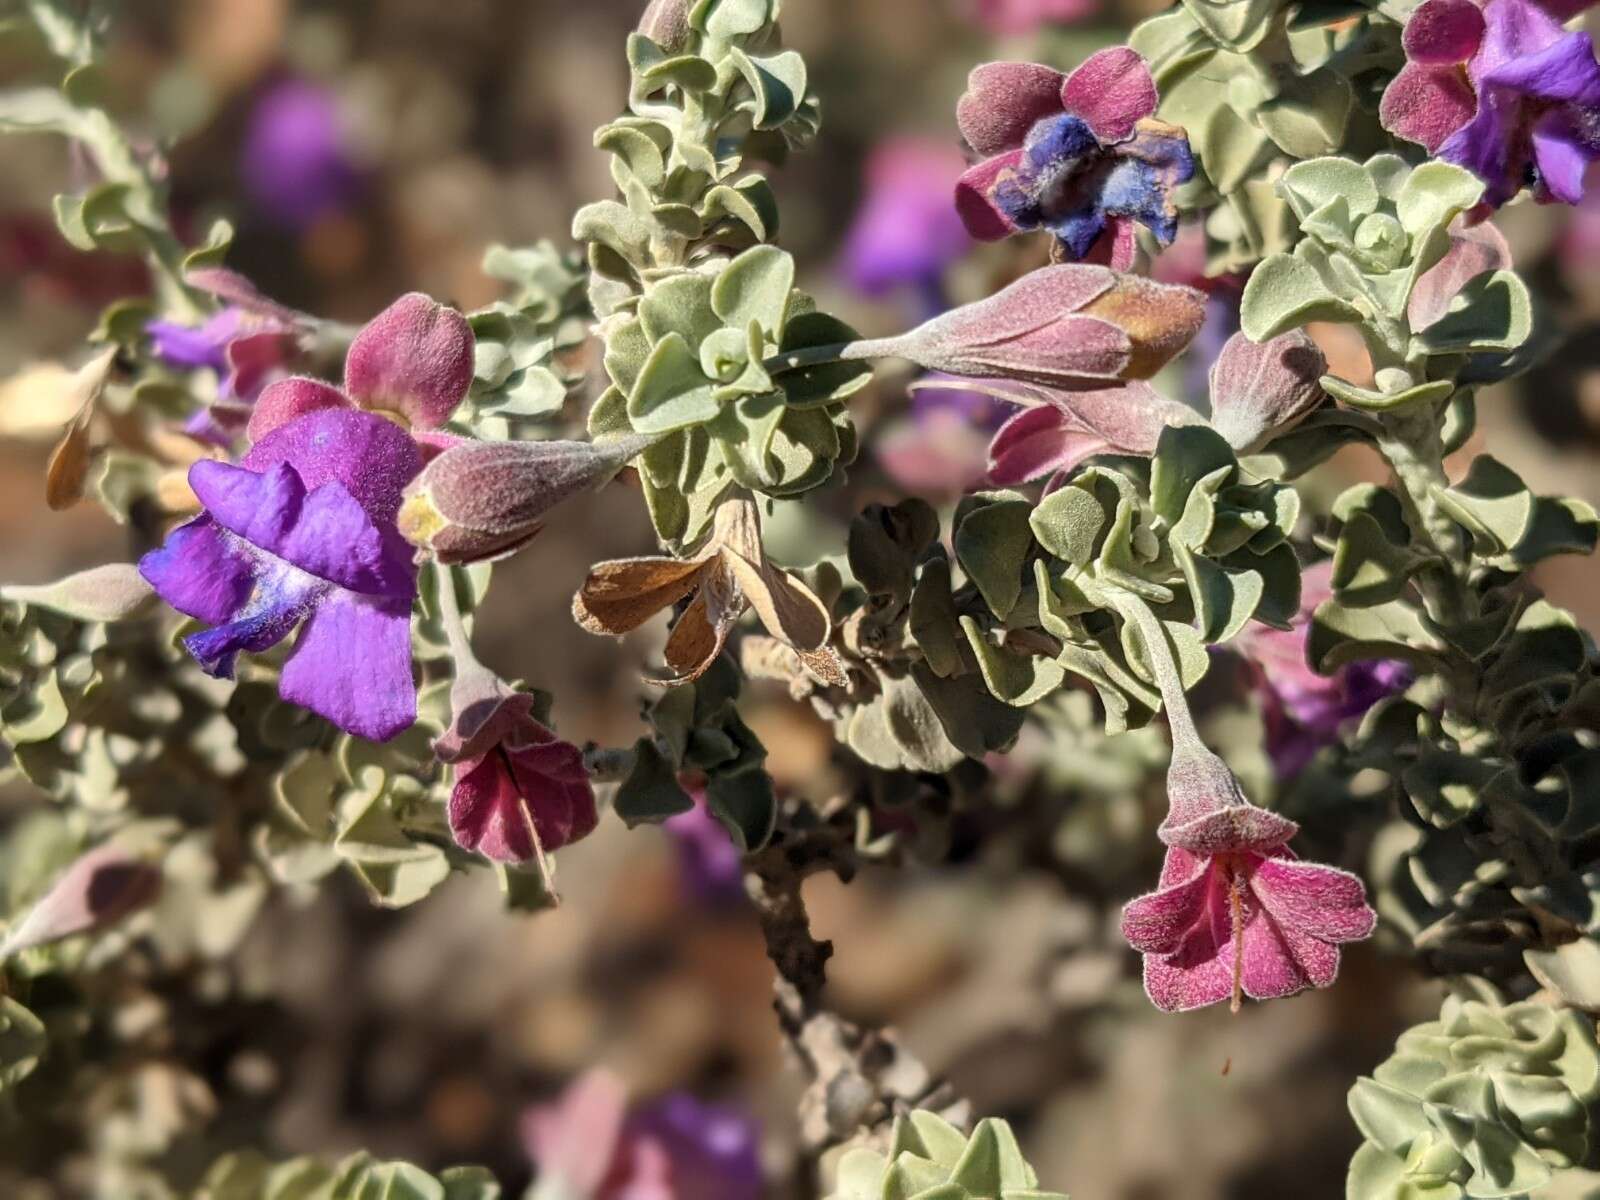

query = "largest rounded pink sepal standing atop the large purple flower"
[[344, 291, 474, 429]]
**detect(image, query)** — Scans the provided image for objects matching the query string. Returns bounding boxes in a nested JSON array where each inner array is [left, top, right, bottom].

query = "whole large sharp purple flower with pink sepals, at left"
[[139, 294, 472, 741]]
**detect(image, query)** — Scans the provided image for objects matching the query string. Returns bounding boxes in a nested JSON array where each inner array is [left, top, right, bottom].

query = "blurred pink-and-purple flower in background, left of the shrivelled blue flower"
[[842, 138, 971, 314]]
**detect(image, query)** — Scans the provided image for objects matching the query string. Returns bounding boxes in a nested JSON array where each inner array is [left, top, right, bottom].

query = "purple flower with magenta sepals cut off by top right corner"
[[1379, 0, 1600, 208]]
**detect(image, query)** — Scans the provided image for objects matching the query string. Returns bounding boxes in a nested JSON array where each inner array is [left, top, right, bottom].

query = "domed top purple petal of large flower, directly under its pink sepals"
[[240, 408, 422, 525]]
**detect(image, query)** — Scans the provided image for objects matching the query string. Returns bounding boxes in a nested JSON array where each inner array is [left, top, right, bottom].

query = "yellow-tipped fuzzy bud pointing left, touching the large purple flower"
[[400, 437, 651, 563]]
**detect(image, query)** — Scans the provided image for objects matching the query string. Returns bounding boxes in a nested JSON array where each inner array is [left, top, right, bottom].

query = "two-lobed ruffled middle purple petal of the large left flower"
[[189, 459, 416, 600]]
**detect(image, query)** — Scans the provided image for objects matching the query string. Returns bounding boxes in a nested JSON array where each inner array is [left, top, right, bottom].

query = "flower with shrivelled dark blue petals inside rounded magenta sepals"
[[955, 46, 1194, 270]]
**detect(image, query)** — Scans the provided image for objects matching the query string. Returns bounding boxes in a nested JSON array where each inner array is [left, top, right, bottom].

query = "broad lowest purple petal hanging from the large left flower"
[[278, 589, 416, 742]]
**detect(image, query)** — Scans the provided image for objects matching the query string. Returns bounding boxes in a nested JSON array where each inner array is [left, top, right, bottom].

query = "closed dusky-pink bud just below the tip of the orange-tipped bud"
[[1211, 330, 1328, 454]]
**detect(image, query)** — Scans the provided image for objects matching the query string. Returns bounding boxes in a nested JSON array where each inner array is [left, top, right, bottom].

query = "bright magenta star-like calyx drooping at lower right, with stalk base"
[[1122, 744, 1378, 1013]]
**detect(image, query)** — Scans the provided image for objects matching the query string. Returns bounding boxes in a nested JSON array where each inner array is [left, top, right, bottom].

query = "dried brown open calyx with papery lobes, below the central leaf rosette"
[[573, 499, 832, 683]]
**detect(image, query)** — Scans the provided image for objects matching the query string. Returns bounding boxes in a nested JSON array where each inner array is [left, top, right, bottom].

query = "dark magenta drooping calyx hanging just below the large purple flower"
[[434, 659, 598, 866]]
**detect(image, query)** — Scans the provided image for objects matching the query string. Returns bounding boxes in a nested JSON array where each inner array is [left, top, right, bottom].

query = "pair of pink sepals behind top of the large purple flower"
[[248, 291, 474, 458]]
